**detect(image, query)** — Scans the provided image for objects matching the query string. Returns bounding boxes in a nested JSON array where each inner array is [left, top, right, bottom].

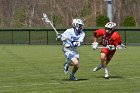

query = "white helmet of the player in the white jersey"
[[72, 19, 84, 33]]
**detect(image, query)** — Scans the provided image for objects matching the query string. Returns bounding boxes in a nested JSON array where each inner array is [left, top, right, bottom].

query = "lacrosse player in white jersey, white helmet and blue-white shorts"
[[57, 19, 85, 80]]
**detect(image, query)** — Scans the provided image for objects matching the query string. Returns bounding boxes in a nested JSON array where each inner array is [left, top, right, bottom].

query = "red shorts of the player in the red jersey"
[[101, 48, 116, 61]]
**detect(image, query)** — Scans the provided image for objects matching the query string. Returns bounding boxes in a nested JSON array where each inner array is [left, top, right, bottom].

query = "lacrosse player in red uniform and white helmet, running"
[[92, 22, 124, 79]]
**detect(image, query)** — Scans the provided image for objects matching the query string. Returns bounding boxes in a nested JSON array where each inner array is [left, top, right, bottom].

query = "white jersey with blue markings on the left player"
[[61, 28, 85, 52]]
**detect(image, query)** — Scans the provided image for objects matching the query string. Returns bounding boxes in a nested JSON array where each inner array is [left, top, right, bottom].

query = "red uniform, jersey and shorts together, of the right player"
[[94, 29, 121, 61]]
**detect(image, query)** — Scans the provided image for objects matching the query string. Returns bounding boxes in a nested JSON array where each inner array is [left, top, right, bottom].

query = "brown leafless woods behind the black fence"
[[0, 0, 140, 28]]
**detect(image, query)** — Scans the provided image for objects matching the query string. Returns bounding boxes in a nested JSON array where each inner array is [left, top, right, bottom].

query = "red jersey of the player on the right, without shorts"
[[94, 29, 121, 46]]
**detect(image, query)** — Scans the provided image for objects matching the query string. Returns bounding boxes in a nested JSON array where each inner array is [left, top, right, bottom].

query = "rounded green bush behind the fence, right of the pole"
[[123, 16, 136, 27]]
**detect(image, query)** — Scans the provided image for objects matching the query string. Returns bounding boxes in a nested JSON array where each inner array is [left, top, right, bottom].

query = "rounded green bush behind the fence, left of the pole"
[[95, 15, 109, 27]]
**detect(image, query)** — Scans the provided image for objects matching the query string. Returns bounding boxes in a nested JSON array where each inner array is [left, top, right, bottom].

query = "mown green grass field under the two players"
[[0, 45, 140, 93]]
